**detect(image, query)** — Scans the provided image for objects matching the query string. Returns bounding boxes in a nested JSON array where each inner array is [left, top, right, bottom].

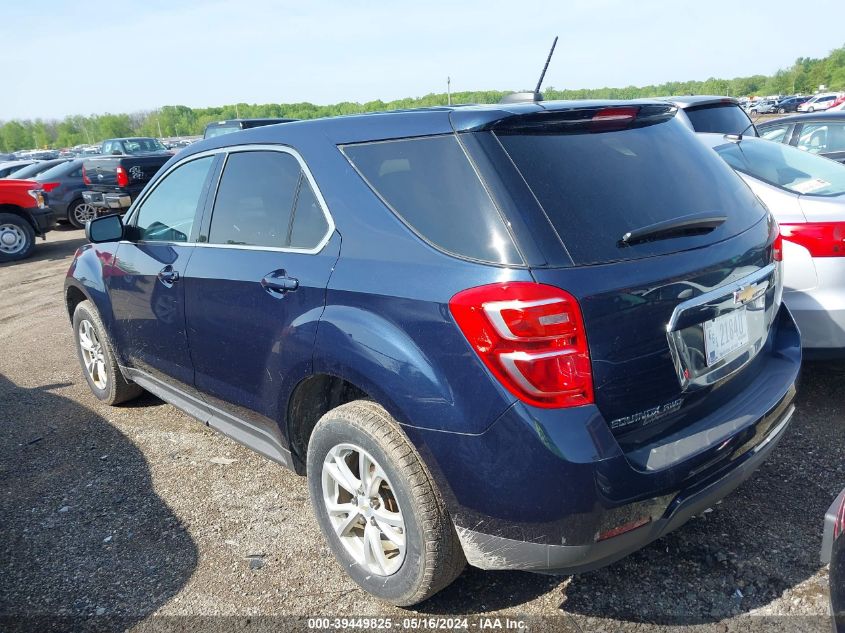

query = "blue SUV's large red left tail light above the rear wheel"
[[449, 282, 593, 408]]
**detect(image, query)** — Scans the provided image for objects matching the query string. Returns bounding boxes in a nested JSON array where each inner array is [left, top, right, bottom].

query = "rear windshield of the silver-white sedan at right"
[[715, 139, 845, 196]]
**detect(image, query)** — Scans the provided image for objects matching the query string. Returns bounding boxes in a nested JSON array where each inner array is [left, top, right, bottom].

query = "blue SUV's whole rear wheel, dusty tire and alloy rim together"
[[307, 400, 466, 606]]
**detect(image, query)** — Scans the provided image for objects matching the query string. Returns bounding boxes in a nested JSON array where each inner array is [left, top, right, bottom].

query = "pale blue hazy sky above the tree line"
[[0, 0, 845, 120]]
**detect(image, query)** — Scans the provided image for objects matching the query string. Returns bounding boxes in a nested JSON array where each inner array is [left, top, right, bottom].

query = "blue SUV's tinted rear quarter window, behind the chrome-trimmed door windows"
[[343, 135, 522, 264]]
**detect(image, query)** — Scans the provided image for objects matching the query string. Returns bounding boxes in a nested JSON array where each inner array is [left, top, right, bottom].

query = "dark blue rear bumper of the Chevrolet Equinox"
[[405, 306, 801, 573]]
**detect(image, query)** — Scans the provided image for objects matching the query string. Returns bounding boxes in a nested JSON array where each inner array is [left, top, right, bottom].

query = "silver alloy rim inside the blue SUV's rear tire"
[[322, 444, 406, 576]]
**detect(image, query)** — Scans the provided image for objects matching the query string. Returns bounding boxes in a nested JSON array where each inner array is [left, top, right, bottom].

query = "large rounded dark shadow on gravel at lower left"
[[0, 374, 197, 631]]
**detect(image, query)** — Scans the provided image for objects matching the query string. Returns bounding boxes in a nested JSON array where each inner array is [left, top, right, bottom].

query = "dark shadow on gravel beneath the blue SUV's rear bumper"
[[419, 363, 845, 624]]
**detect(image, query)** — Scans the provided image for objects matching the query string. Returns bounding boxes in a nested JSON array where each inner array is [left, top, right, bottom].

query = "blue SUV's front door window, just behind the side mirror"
[[135, 156, 214, 242]]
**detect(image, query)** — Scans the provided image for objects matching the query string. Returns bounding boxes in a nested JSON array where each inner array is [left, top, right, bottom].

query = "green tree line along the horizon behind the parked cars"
[[0, 46, 845, 152]]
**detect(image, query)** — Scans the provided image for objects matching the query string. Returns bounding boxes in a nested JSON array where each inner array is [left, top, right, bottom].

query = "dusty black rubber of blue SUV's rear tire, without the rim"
[[307, 400, 466, 606]]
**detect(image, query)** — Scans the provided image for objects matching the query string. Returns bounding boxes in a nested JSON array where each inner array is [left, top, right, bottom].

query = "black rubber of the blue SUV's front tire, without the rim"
[[73, 301, 144, 405]]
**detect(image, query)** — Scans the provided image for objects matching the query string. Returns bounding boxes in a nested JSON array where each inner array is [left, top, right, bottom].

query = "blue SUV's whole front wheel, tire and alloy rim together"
[[73, 301, 143, 405]]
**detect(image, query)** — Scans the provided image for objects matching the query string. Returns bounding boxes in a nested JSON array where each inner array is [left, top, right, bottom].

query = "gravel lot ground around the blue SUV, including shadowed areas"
[[0, 230, 845, 633]]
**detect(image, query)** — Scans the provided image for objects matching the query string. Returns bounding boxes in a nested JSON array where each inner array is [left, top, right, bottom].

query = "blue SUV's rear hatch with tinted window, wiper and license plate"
[[473, 105, 780, 450]]
